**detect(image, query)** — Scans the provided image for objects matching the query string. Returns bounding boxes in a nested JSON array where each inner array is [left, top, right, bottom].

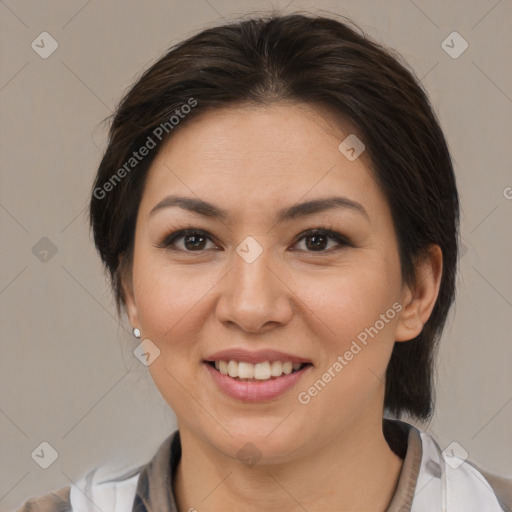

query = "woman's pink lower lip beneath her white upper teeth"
[[203, 363, 311, 402]]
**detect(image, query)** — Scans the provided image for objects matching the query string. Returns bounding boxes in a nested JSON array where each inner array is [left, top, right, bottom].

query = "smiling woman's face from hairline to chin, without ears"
[[127, 104, 420, 461]]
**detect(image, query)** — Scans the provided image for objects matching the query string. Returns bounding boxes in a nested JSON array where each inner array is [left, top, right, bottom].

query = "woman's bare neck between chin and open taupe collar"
[[174, 415, 403, 512]]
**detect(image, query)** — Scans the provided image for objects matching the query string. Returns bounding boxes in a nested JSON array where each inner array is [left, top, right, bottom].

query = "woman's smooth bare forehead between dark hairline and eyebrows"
[[141, 103, 385, 223]]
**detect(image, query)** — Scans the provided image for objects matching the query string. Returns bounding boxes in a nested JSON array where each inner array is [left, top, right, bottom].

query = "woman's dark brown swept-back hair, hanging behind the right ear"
[[90, 14, 459, 419]]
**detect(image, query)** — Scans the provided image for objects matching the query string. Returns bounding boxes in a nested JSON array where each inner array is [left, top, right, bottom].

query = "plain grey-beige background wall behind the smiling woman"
[[0, 0, 512, 510]]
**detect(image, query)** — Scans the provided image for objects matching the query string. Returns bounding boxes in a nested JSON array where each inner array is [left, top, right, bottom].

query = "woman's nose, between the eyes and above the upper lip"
[[217, 246, 294, 334]]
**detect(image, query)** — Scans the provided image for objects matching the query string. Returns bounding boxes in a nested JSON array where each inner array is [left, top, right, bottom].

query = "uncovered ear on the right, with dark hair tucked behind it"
[[395, 244, 443, 341]]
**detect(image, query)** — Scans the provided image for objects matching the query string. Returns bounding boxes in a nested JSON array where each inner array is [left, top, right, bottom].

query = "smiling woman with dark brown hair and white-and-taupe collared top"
[[15, 10, 512, 512]]
